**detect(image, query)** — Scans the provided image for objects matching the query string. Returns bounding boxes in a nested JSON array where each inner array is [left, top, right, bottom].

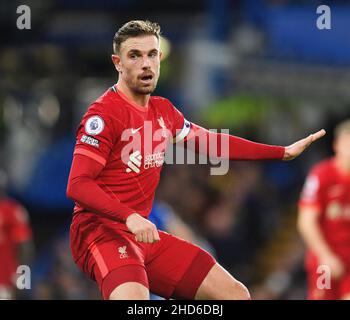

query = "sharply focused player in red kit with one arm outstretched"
[[67, 21, 325, 300]]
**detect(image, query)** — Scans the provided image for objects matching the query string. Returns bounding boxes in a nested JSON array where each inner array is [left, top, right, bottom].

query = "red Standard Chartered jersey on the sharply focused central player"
[[74, 86, 190, 221]]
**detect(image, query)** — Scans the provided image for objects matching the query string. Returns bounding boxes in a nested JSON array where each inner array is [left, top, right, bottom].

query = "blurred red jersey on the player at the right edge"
[[299, 158, 350, 264]]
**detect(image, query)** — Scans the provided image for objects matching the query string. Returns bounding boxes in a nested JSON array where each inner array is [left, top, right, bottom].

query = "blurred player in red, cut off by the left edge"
[[0, 171, 33, 299]]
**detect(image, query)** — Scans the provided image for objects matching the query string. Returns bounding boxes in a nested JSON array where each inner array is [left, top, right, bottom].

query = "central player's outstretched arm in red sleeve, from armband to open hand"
[[185, 123, 326, 161]]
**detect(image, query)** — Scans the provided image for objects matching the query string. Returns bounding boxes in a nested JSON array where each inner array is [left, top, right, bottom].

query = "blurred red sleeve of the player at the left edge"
[[9, 205, 32, 243]]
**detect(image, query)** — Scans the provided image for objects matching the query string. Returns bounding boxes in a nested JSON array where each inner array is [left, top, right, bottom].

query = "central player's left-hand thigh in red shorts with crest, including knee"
[[83, 232, 149, 299]]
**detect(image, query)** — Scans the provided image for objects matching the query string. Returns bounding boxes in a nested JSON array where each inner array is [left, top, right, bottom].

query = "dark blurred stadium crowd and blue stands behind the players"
[[0, 0, 350, 299]]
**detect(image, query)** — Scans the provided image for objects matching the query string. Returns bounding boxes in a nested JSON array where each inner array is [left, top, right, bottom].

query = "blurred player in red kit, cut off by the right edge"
[[298, 120, 350, 300]]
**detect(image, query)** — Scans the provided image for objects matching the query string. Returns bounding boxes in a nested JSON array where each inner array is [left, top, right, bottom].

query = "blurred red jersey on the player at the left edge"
[[0, 199, 32, 286]]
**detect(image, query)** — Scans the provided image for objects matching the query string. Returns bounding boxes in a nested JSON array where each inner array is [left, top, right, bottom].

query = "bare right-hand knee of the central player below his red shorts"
[[195, 263, 250, 300]]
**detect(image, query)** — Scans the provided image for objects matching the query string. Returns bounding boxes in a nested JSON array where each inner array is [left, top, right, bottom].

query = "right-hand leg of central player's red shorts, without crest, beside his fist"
[[146, 231, 216, 299]]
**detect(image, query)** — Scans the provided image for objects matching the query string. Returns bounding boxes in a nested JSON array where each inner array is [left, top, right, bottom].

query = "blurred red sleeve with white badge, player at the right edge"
[[299, 168, 323, 208]]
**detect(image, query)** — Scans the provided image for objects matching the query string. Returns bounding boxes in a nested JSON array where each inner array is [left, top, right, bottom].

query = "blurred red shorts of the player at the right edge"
[[306, 255, 350, 300]]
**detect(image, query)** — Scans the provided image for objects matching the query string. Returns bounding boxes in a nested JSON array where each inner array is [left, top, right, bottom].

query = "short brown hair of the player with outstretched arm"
[[113, 20, 160, 54]]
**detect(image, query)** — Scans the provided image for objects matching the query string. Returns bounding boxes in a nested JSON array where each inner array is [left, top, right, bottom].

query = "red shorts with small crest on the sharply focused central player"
[[71, 218, 216, 299]]
